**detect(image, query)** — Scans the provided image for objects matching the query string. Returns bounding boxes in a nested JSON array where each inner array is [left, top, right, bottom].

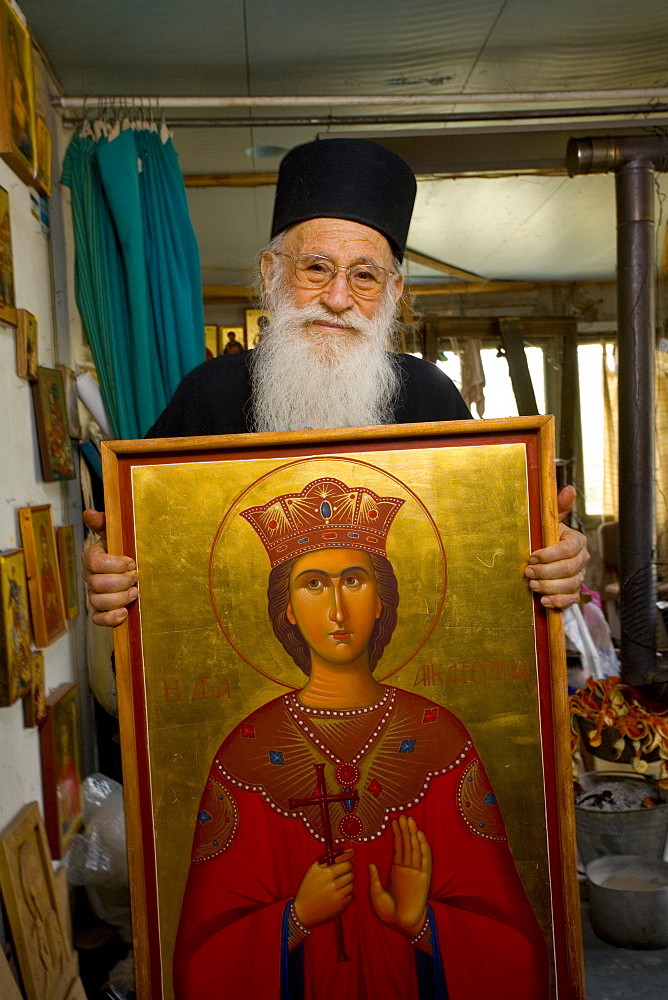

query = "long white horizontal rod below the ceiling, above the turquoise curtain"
[[51, 87, 668, 109]]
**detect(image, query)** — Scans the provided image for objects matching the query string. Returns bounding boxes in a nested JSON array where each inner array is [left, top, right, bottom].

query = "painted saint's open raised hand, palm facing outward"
[[369, 816, 431, 937]]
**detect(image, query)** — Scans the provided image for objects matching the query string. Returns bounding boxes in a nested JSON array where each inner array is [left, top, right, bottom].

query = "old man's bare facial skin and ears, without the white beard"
[[262, 219, 403, 326]]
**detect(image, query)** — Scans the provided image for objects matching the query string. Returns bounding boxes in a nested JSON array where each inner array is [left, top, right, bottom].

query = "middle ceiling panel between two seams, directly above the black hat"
[[246, 0, 503, 94]]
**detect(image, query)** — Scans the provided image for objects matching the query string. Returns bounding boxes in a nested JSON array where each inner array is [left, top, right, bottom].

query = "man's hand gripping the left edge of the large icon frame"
[[81, 510, 138, 626]]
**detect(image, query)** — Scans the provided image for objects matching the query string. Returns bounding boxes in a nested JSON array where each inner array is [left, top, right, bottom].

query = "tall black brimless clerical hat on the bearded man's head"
[[271, 139, 417, 260]]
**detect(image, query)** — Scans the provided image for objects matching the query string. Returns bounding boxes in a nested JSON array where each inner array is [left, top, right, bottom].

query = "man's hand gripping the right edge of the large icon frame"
[[524, 486, 589, 608]]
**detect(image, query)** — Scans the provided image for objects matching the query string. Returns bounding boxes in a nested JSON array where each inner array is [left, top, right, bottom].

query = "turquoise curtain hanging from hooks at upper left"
[[62, 128, 204, 438]]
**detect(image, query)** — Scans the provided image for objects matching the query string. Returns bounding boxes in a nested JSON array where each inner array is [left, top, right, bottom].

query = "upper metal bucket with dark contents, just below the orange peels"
[[575, 771, 668, 866]]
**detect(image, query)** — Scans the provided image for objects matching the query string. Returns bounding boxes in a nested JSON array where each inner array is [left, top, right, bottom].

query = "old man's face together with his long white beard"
[[252, 219, 403, 431]]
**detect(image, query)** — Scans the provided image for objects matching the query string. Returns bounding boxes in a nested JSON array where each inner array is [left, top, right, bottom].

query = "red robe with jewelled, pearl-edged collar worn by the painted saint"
[[174, 687, 548, 1000]]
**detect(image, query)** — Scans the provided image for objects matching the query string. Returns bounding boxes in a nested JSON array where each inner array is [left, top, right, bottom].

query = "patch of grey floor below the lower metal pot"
[[582, 893, 668, 1000]]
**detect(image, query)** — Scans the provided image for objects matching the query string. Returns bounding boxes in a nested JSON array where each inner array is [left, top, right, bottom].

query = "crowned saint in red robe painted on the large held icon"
[[174, 477, 548, 1000]]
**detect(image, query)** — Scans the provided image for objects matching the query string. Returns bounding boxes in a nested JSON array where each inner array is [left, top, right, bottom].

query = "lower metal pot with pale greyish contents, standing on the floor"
[[587, 854, 668, 948]]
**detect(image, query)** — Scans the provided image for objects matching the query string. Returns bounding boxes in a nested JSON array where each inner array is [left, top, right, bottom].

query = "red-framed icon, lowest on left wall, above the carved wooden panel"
[[39, 684, 83, 858]]
